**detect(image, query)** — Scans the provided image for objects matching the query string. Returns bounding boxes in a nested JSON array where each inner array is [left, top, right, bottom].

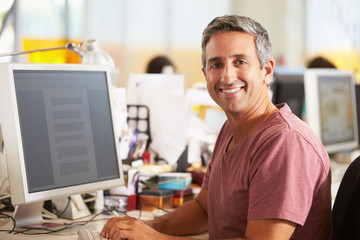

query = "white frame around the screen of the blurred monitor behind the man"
[[304, 69, 359, 154]]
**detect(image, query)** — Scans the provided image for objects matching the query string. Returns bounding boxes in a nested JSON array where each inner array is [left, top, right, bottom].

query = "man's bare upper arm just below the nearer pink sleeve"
[[218, 219, 296, 240]]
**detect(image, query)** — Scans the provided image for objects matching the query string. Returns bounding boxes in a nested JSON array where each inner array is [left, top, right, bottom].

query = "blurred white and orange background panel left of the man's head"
[[84, 0, 231, 88]]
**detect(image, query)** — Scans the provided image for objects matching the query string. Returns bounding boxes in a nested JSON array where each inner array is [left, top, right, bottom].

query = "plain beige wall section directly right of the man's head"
[[233, 0, 306, 66]]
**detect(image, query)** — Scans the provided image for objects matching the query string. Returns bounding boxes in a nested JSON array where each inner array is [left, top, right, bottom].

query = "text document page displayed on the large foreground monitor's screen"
[[44, 89, 97, 185]]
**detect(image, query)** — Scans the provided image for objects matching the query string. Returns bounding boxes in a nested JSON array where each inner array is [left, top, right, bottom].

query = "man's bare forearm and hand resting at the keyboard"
[[101, 190, 208, 240]]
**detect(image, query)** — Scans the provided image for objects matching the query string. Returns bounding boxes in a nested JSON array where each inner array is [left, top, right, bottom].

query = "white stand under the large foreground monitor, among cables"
[[13, 201, 57, 227]]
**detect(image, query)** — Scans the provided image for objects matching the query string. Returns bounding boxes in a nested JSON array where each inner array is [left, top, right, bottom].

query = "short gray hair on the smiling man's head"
[[201, 15, 272, 69]]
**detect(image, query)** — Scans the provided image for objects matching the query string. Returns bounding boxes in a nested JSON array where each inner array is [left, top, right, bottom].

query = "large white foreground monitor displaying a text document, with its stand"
[[0, 63, 124, 225]]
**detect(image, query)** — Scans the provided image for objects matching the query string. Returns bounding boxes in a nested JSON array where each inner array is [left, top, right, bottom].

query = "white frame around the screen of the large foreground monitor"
[[0, 63, 124, 205]]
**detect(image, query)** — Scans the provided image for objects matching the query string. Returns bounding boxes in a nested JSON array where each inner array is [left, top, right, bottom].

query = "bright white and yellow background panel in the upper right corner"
[[306, 0, 360, 83]]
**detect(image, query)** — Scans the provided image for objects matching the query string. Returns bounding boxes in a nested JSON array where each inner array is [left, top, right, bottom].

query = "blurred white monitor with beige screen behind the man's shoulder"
[[304, 69, 358, 154]]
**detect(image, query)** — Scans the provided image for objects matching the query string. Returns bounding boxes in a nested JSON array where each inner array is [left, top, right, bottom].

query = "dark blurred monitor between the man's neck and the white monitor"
[[271, 68, 305, 118]]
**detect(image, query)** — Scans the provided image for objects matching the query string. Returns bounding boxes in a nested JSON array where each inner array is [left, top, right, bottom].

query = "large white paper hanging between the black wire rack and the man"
[[127, 74, 189, 164]]
